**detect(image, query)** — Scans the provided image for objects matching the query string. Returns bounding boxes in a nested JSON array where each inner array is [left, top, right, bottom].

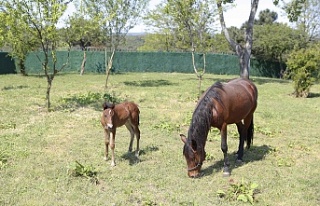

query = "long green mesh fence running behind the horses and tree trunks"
[[4, 51, 280, 77]]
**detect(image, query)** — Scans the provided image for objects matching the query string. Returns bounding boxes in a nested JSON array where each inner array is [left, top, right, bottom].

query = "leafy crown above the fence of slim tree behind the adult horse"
[[144, 0, 216, 51]]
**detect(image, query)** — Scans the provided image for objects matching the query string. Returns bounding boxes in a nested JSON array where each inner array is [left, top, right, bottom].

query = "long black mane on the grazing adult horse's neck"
[[188, 82, 223, 146]]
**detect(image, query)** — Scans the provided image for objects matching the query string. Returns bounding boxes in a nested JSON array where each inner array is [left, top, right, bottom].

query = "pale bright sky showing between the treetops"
[[61, 0, 289, 33]]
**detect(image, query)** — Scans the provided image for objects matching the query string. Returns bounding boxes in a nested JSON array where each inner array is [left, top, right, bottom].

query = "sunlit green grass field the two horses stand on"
[[0, 73, 320, 206]]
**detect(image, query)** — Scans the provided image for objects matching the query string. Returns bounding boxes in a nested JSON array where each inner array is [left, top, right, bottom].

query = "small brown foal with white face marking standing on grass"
[[101, 102, 140, 166]]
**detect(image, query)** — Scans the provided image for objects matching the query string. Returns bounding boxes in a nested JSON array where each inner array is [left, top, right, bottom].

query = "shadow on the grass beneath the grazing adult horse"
[[201, 145, 272, 176]]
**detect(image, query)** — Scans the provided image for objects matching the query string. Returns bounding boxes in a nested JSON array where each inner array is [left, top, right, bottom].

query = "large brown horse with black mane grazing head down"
[[180, 78, 258, 177]]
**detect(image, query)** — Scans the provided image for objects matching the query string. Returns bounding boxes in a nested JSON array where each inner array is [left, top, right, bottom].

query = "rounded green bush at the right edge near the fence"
[[286, 45, 320, 97]]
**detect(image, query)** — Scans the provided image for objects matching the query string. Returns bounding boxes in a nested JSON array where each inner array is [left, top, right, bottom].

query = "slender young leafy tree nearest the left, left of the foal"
[[3, 0, 70, 110]]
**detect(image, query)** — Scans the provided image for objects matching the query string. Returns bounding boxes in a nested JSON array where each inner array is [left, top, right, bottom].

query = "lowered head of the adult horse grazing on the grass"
[[180, 134, 203, 177]]
